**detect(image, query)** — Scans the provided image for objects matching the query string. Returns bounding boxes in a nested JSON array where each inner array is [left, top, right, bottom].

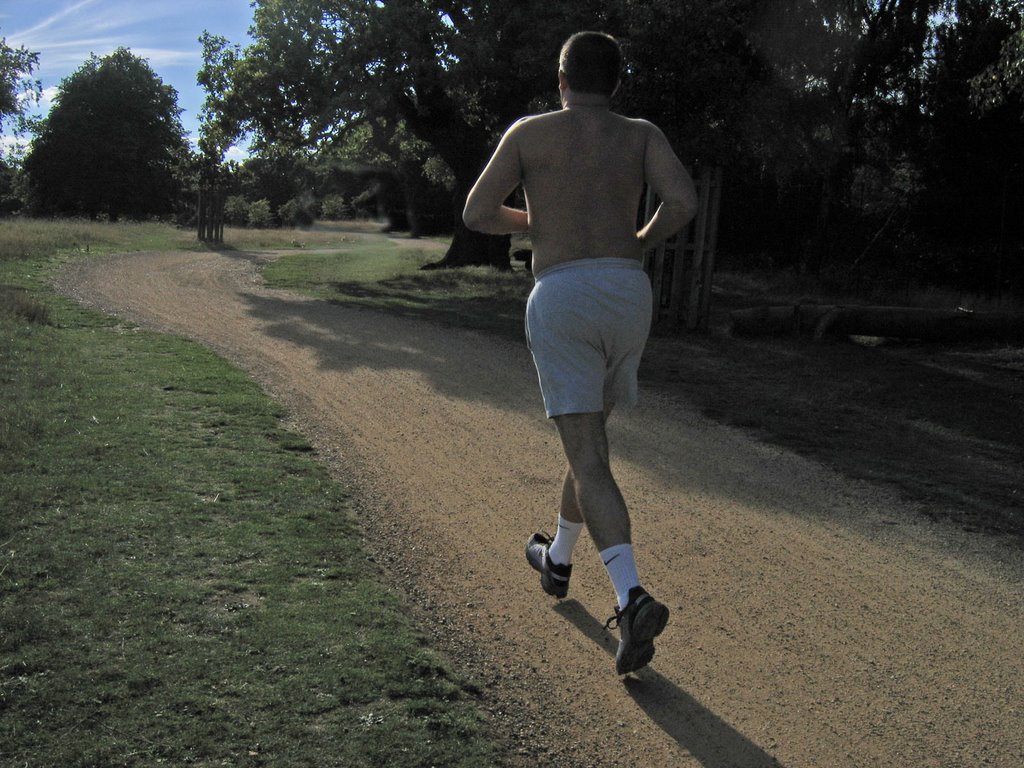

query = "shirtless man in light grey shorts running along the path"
[[463, 32, 696, 675]]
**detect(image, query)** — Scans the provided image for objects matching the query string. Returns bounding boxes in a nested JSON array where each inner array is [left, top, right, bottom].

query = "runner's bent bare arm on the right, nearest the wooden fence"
[[637, 125, 697, 248]]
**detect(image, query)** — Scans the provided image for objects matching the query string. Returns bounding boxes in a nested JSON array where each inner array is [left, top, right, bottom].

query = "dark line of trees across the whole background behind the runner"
[[0, 0, 1024, 291]]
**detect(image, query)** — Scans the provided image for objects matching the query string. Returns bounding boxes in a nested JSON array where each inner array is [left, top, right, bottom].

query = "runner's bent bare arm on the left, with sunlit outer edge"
[[462, 125, 529, 234]]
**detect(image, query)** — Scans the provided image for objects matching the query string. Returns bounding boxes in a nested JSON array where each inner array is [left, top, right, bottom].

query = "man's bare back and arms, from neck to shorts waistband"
[[466, 91, 696, 274]]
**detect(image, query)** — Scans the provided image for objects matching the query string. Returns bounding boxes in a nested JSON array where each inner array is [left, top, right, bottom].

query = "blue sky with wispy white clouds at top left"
[[0, 0, 252, 156]]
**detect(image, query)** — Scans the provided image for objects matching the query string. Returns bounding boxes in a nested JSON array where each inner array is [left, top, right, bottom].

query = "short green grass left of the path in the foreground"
[[0, 222, 499, 766]]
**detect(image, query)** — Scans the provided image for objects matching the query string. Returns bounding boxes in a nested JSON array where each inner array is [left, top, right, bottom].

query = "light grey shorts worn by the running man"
[[526, 258, 652, 418]]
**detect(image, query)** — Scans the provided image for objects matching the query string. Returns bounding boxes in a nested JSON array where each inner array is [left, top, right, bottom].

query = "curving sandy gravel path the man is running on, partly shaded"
[[61, 253, 1024, 768]]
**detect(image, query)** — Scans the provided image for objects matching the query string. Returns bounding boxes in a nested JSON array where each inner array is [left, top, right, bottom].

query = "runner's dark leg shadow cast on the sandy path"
[[554, 600, 781, 768]]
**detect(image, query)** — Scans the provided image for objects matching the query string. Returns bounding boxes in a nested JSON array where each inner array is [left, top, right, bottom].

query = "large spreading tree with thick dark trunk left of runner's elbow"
[[201, 0, 609, 266]]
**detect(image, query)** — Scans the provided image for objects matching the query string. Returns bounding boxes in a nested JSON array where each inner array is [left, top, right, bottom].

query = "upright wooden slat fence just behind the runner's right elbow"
[[644, 168, 722, 333]]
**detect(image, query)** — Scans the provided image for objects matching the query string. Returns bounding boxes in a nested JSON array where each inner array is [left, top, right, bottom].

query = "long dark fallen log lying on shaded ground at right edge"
[[730, 304, 1024, 343]]
